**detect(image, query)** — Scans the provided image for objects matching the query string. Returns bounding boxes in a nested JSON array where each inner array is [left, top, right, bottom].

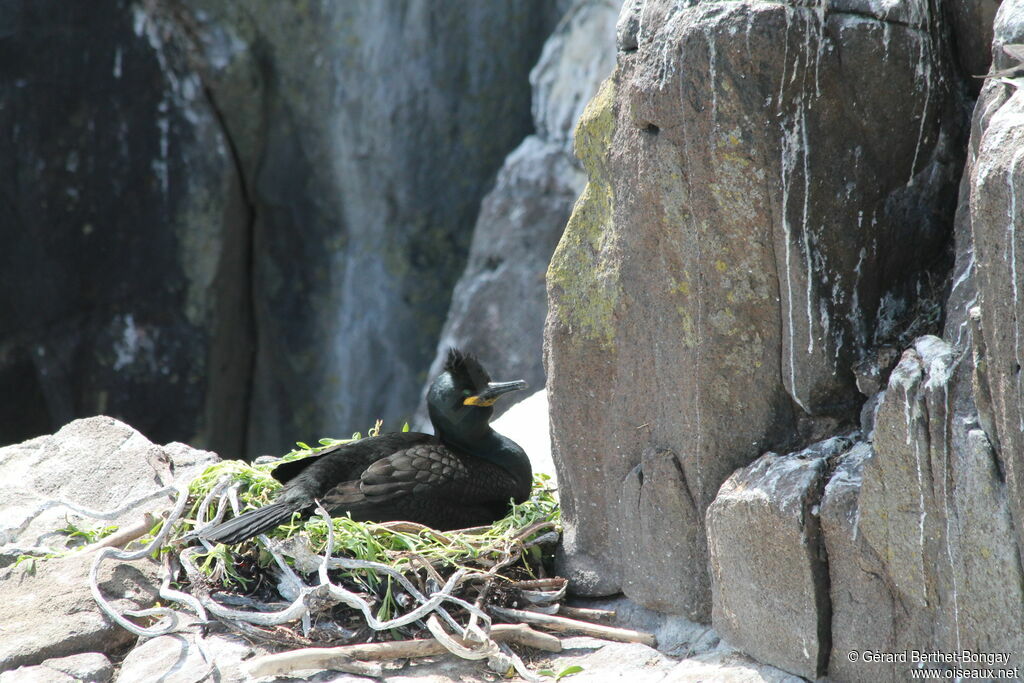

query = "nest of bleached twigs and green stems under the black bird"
[[91, 432, 647, 680]]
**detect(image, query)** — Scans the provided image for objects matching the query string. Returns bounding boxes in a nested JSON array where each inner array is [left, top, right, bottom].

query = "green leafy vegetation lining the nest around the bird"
[[137, 423, 560, 634]]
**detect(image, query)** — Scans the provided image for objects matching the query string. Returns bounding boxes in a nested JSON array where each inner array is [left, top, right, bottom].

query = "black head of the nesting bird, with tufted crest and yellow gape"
[[427, 348, 526, 436]]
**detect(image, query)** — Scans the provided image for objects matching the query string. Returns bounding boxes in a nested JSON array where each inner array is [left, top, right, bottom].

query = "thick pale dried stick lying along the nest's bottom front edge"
[[246, 624, 562, 678]]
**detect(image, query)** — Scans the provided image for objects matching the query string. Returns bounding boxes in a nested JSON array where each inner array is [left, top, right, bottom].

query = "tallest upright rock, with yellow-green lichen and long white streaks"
[[545, 0, 963, 618]]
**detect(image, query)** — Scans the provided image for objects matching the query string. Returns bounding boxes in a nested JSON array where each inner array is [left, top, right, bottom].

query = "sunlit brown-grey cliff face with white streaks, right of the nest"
[[545, 0, 1024, 680]]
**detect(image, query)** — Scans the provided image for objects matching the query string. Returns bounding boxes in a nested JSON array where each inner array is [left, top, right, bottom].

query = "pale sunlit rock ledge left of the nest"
[[0, 416, 216, 680]]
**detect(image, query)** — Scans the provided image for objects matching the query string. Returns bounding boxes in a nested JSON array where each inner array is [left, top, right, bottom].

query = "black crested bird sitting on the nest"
[[199, 349, 532, 544]]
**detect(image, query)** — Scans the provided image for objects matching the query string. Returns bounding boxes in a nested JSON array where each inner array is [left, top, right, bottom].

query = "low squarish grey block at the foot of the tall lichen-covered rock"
[[707, 438, 850, 679]]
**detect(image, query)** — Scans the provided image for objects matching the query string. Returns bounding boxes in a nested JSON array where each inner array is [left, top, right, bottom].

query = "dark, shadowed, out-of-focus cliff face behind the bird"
[[0, 0, 560, 455]]
